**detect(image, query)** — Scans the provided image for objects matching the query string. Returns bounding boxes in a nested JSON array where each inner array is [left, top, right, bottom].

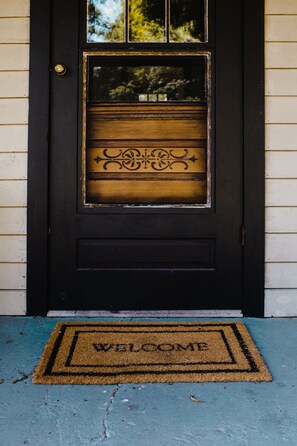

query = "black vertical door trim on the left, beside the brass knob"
[[27, 0, 51, 316]]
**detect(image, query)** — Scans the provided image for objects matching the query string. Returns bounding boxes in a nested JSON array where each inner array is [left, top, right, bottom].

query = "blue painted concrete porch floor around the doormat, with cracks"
[[0, 317, 297, 446]]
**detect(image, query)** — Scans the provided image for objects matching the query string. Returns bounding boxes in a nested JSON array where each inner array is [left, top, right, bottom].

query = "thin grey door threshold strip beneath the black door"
[[47, 310, 243, 318]]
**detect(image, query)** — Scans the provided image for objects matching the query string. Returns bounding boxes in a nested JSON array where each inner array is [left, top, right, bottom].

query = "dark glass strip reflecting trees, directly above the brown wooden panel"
[[88, 56, 206, 102]]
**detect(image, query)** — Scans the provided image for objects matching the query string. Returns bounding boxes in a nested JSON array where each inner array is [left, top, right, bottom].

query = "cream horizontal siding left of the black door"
[[0, 0, 29, 315]]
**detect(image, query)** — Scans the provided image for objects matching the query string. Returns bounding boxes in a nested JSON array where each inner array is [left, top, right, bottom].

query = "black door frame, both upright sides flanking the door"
[[27, 0, 265, 317]]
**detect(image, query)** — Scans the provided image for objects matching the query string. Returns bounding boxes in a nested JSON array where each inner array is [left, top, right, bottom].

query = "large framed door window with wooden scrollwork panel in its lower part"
[[83, 52, 210, 206]]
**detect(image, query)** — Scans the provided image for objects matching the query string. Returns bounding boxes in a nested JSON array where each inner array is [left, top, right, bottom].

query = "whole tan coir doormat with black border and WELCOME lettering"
[[33, 322, 272, 384]]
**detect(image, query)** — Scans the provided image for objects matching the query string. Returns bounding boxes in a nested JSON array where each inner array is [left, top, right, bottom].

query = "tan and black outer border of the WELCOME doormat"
[[32, 321, 272, 384]]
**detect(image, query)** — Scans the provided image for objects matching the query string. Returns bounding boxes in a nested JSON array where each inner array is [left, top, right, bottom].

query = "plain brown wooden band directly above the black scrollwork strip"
[[87, 104, 207, 141]]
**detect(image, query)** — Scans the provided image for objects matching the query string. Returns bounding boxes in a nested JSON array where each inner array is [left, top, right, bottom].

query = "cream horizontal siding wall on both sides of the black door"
[[0, 0, 297, 317]]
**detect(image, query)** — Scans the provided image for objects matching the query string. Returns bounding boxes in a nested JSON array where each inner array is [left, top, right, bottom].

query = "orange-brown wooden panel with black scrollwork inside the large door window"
[[86, 103, 207, 204]]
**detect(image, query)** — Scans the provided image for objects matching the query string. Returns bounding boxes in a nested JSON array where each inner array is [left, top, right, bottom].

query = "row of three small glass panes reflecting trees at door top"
[[88, 0, 205, 42]]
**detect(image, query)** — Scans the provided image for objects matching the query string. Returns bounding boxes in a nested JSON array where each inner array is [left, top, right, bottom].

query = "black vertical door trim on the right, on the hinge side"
[[243, 0, 265, 317]]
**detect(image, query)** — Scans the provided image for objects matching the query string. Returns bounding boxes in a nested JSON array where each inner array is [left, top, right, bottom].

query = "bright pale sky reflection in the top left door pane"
[[91, 0, 123, 42]]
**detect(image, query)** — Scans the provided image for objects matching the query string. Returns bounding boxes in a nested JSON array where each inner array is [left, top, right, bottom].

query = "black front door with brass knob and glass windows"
[[49, 0, 243, 311]]
